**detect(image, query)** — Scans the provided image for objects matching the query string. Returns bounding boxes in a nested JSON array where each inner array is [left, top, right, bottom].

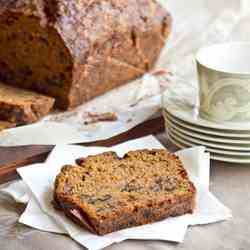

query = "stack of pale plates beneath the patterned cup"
[[163, 84, 250, 164]]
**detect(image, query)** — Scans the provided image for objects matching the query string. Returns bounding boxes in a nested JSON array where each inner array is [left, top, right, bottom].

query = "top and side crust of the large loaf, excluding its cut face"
[[0, 0, 172, 107]]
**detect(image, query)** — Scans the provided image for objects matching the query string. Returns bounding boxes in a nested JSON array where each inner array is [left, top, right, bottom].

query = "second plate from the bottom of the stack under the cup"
[[168, 127, 250, 152]]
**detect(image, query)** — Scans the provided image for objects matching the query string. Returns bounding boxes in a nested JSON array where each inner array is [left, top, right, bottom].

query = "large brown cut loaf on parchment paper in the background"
[[0, 0, 171, 109]]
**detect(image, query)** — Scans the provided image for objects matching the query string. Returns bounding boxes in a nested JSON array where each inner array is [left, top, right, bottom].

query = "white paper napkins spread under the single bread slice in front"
[[1, 136, 232, 250]]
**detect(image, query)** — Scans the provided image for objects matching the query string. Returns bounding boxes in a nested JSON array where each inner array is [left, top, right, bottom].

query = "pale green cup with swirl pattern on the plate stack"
[[196, 42, 250, 123]]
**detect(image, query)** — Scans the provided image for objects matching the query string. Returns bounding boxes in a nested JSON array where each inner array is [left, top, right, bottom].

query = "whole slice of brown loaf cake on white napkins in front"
[[54, 150, 196, 235]]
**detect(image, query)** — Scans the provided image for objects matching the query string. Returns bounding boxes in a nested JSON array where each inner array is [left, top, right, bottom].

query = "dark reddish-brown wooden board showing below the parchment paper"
[[0, 117, 164, 184]]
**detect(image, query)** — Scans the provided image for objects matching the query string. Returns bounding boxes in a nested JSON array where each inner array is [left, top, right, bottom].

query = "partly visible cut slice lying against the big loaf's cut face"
[[0, 83, 54, 125]]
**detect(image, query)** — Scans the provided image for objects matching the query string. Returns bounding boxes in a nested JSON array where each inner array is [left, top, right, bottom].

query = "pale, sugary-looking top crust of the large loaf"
[[0, 0, 172, 63]]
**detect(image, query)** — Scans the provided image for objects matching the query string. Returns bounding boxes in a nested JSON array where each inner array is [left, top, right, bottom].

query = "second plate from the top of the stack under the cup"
[[163, 110, 250, 140]]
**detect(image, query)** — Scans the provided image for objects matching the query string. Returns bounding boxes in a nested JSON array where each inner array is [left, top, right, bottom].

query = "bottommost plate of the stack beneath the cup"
[[169, 133, 250, 164]]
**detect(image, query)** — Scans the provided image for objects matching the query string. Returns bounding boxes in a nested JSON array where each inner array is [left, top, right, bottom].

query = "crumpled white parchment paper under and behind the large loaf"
[[0, 0, 244, 146]]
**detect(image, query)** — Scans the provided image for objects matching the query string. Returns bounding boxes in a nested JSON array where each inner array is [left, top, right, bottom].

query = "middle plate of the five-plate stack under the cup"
[[165, 115, 250, 145]]
